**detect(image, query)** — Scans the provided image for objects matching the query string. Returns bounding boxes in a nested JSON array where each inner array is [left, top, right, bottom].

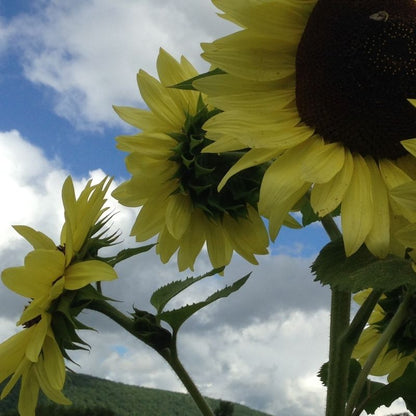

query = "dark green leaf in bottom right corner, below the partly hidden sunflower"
[[364, 361, 416, 414]]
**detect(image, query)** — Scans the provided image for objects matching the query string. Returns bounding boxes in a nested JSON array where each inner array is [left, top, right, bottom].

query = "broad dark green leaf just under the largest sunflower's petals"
[[311, 239, 416, 292]]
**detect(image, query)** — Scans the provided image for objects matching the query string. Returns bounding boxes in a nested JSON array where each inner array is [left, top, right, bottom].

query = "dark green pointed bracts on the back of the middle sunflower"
[[170, 99, 265, 220]]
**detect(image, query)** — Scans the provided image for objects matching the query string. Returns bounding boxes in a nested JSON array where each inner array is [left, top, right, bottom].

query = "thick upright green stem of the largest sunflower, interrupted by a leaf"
[[321, 215, 351, 416]]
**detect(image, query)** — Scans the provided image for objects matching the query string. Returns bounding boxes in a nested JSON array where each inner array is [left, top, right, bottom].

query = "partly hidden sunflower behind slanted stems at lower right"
[[352, 288, 416, 382]]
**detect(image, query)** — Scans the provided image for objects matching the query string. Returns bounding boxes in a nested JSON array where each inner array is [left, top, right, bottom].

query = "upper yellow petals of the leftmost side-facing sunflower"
[[1, 177, 117, 324]]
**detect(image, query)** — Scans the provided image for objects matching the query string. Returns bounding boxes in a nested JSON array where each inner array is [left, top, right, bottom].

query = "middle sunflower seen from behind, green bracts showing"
[[113, 50, 268, 270]]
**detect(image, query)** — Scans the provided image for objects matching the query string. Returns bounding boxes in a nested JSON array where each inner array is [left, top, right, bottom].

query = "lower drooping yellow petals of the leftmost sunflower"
[[0, 313, 71, 416]]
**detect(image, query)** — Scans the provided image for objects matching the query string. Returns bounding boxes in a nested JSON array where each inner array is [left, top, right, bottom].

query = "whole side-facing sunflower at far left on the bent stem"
[[0, 177, 117, 416]]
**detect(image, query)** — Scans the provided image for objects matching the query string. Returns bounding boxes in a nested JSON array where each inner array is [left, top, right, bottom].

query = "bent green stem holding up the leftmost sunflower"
[[88, 300, 214, 416]]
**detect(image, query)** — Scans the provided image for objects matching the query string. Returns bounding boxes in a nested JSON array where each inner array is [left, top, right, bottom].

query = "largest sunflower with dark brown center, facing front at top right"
[[194, 0, 416, 257]]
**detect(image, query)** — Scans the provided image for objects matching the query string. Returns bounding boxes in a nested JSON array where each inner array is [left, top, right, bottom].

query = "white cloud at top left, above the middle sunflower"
[[4, 0, 236, 129]]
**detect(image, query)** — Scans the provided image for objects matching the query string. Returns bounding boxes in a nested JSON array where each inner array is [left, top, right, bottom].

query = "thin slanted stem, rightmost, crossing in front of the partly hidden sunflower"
[[345, 291, 413, 416]]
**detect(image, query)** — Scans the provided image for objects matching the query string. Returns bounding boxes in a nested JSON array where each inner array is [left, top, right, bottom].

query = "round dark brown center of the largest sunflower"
[[296, 0, 416, 160]]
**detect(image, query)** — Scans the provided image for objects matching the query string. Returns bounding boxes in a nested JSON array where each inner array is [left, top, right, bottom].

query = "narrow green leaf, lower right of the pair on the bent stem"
[[159, 273, 250, 333]]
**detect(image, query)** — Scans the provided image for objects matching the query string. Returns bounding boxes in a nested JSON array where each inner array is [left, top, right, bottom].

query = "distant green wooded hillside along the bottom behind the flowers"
[[0, 373, 270, 416]]
